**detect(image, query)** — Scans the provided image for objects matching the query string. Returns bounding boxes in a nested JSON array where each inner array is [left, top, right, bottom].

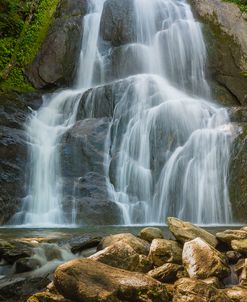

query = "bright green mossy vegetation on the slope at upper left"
[[0, 0, 59, 91]]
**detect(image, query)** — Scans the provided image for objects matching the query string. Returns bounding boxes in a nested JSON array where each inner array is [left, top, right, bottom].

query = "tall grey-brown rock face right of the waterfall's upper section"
[[190, 0, 247, 105]]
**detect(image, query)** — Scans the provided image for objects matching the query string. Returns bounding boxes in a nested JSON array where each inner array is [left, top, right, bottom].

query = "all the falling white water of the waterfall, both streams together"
[[13, 0, 231, 226]]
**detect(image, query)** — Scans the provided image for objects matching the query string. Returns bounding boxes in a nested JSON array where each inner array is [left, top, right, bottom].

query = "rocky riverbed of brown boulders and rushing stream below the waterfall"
[[0, 217, 247, 302]]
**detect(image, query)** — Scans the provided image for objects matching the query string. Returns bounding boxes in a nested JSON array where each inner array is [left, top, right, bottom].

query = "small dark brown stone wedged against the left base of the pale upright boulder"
[[148, 263, 184, 283]]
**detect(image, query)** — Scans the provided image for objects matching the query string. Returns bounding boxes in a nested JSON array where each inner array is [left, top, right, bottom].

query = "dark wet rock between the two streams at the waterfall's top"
[[100, 0, 136, 46]]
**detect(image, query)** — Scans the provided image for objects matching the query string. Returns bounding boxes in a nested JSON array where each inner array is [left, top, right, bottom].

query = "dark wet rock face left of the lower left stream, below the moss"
[[0, 93, 41, 224]]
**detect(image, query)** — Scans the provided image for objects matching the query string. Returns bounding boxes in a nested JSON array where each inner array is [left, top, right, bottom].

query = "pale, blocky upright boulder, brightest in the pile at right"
[[183, 237, 230, 279]]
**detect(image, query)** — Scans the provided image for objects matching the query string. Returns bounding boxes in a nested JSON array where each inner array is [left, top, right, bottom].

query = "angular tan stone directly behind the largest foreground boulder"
[[89, 241, 152, 273]]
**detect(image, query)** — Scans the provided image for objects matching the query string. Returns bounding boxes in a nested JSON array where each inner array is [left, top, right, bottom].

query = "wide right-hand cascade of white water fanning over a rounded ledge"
[[101, 0, 231, 224]]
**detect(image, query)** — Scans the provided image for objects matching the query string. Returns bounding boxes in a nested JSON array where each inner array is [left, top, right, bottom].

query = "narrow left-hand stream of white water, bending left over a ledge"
[[12, 0, 104, 226]]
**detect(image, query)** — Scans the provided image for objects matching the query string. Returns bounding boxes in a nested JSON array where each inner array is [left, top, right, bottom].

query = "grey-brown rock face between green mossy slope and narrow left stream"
[[26, 0, 88, 89]]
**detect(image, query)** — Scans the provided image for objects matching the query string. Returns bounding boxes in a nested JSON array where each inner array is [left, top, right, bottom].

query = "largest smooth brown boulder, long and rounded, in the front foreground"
[[54, 259, 168, 302]]
